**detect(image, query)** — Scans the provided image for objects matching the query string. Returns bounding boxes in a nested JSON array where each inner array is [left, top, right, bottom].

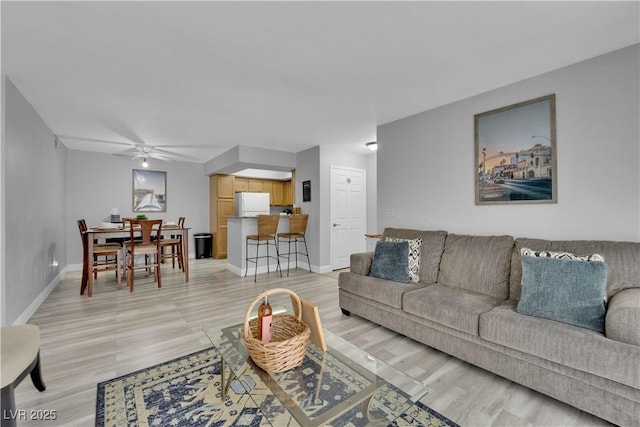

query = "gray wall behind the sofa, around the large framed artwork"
[[377, 45, 640, 241]]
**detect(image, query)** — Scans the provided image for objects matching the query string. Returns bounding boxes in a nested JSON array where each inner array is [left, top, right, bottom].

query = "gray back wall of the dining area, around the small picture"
[[66, 150, 210, 269]]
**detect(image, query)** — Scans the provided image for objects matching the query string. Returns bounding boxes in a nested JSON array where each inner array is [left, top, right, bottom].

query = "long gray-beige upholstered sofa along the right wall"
[[338, 228, 640, 426]]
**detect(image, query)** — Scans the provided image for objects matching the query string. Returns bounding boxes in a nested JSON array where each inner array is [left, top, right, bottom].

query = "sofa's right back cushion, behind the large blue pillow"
[[509, 238, 640, 301]]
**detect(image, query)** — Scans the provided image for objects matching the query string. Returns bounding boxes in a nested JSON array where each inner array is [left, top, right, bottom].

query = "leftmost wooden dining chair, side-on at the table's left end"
[[78, 219, 122, 296]]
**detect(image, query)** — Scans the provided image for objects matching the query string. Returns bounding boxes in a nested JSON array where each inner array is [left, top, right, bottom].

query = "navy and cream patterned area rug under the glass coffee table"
[[96, 348, 457, 427]]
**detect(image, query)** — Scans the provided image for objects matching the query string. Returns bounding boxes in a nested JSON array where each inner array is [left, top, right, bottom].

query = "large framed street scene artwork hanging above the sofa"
[[474, 94, 558, 205]]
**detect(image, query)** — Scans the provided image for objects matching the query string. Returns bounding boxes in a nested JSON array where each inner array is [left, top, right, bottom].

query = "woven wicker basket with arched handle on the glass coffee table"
[[242, 288, 311, 373]]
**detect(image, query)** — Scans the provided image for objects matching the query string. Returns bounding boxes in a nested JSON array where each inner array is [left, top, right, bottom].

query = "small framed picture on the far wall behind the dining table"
[[133, 169, 167, 212]]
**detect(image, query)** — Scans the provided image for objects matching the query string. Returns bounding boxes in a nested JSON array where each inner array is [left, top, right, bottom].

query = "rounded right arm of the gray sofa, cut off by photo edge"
[[605, 288, 640, 346]]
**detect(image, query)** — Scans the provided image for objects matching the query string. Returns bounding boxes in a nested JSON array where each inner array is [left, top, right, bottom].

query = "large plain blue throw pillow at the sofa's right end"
[[516, 256, 608, 332]]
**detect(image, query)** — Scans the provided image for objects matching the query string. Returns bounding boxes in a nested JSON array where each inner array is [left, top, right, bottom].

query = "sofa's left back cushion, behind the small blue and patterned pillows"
[[383, 228, 447, 283]]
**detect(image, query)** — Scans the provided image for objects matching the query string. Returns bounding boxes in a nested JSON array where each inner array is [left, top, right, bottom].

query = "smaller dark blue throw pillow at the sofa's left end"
[[369, 241, 409, 283]]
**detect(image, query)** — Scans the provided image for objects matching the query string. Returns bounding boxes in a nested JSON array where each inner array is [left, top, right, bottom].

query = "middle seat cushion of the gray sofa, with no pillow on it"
[[402, 285, 502, 336]]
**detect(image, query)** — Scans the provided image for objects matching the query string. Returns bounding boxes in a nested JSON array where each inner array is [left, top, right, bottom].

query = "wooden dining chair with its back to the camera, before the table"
[[125, 218, 162, 292]]
